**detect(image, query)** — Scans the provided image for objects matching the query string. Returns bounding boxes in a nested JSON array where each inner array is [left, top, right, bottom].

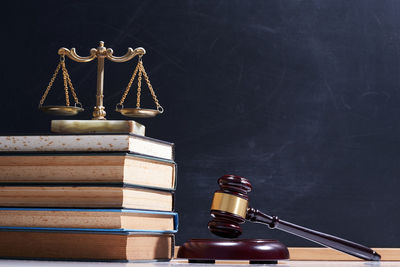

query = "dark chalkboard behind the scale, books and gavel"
[[0, 0, 400, 247]]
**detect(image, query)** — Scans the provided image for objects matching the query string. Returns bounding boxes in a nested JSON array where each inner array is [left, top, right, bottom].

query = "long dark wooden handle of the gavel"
[[246, 208, 381, 261]]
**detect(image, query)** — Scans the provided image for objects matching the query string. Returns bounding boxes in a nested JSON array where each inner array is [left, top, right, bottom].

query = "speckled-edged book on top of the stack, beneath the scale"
[[0, 134, 174, 160]]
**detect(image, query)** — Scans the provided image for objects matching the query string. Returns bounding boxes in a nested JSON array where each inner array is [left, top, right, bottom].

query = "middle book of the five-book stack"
[[0, 184, 174, 211]]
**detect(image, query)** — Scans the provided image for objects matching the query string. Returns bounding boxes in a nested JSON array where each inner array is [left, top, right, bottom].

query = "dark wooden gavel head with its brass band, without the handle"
[[208, 175, 252, 238]]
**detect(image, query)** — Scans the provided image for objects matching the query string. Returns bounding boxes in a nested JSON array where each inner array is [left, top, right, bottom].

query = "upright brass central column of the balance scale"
[[92, 42, 106, 120]]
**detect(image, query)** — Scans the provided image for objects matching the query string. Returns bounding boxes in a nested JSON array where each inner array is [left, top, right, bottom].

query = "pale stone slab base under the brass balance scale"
[[51, 120, 146, 136]]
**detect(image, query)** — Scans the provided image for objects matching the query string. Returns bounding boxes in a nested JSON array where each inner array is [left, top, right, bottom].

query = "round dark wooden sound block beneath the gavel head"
[[178, 239, 289, 263]]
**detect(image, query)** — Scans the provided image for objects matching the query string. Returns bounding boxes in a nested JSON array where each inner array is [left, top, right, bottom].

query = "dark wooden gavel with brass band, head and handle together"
[[208, 175, 381, 261]]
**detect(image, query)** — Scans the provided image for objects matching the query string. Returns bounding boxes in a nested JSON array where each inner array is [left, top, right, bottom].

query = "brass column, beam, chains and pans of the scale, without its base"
[[39, 41, 164, 133]]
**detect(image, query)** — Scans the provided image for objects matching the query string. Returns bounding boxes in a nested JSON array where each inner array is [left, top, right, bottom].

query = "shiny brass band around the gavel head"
[[211, 192, 248, 218]]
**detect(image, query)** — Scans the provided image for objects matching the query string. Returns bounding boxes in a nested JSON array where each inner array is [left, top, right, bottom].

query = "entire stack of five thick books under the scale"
[[0, 129, 178, 261]]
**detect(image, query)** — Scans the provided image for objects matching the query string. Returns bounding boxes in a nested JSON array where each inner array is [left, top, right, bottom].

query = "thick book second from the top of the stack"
[[0, 153, 176, 192]]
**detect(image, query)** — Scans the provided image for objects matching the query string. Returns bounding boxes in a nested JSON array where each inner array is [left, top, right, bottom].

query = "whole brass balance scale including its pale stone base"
[[39, 41, 164, 134]]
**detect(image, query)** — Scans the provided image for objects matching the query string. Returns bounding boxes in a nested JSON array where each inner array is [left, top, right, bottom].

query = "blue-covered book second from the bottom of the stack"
[[0, 208, 178, 234]]
